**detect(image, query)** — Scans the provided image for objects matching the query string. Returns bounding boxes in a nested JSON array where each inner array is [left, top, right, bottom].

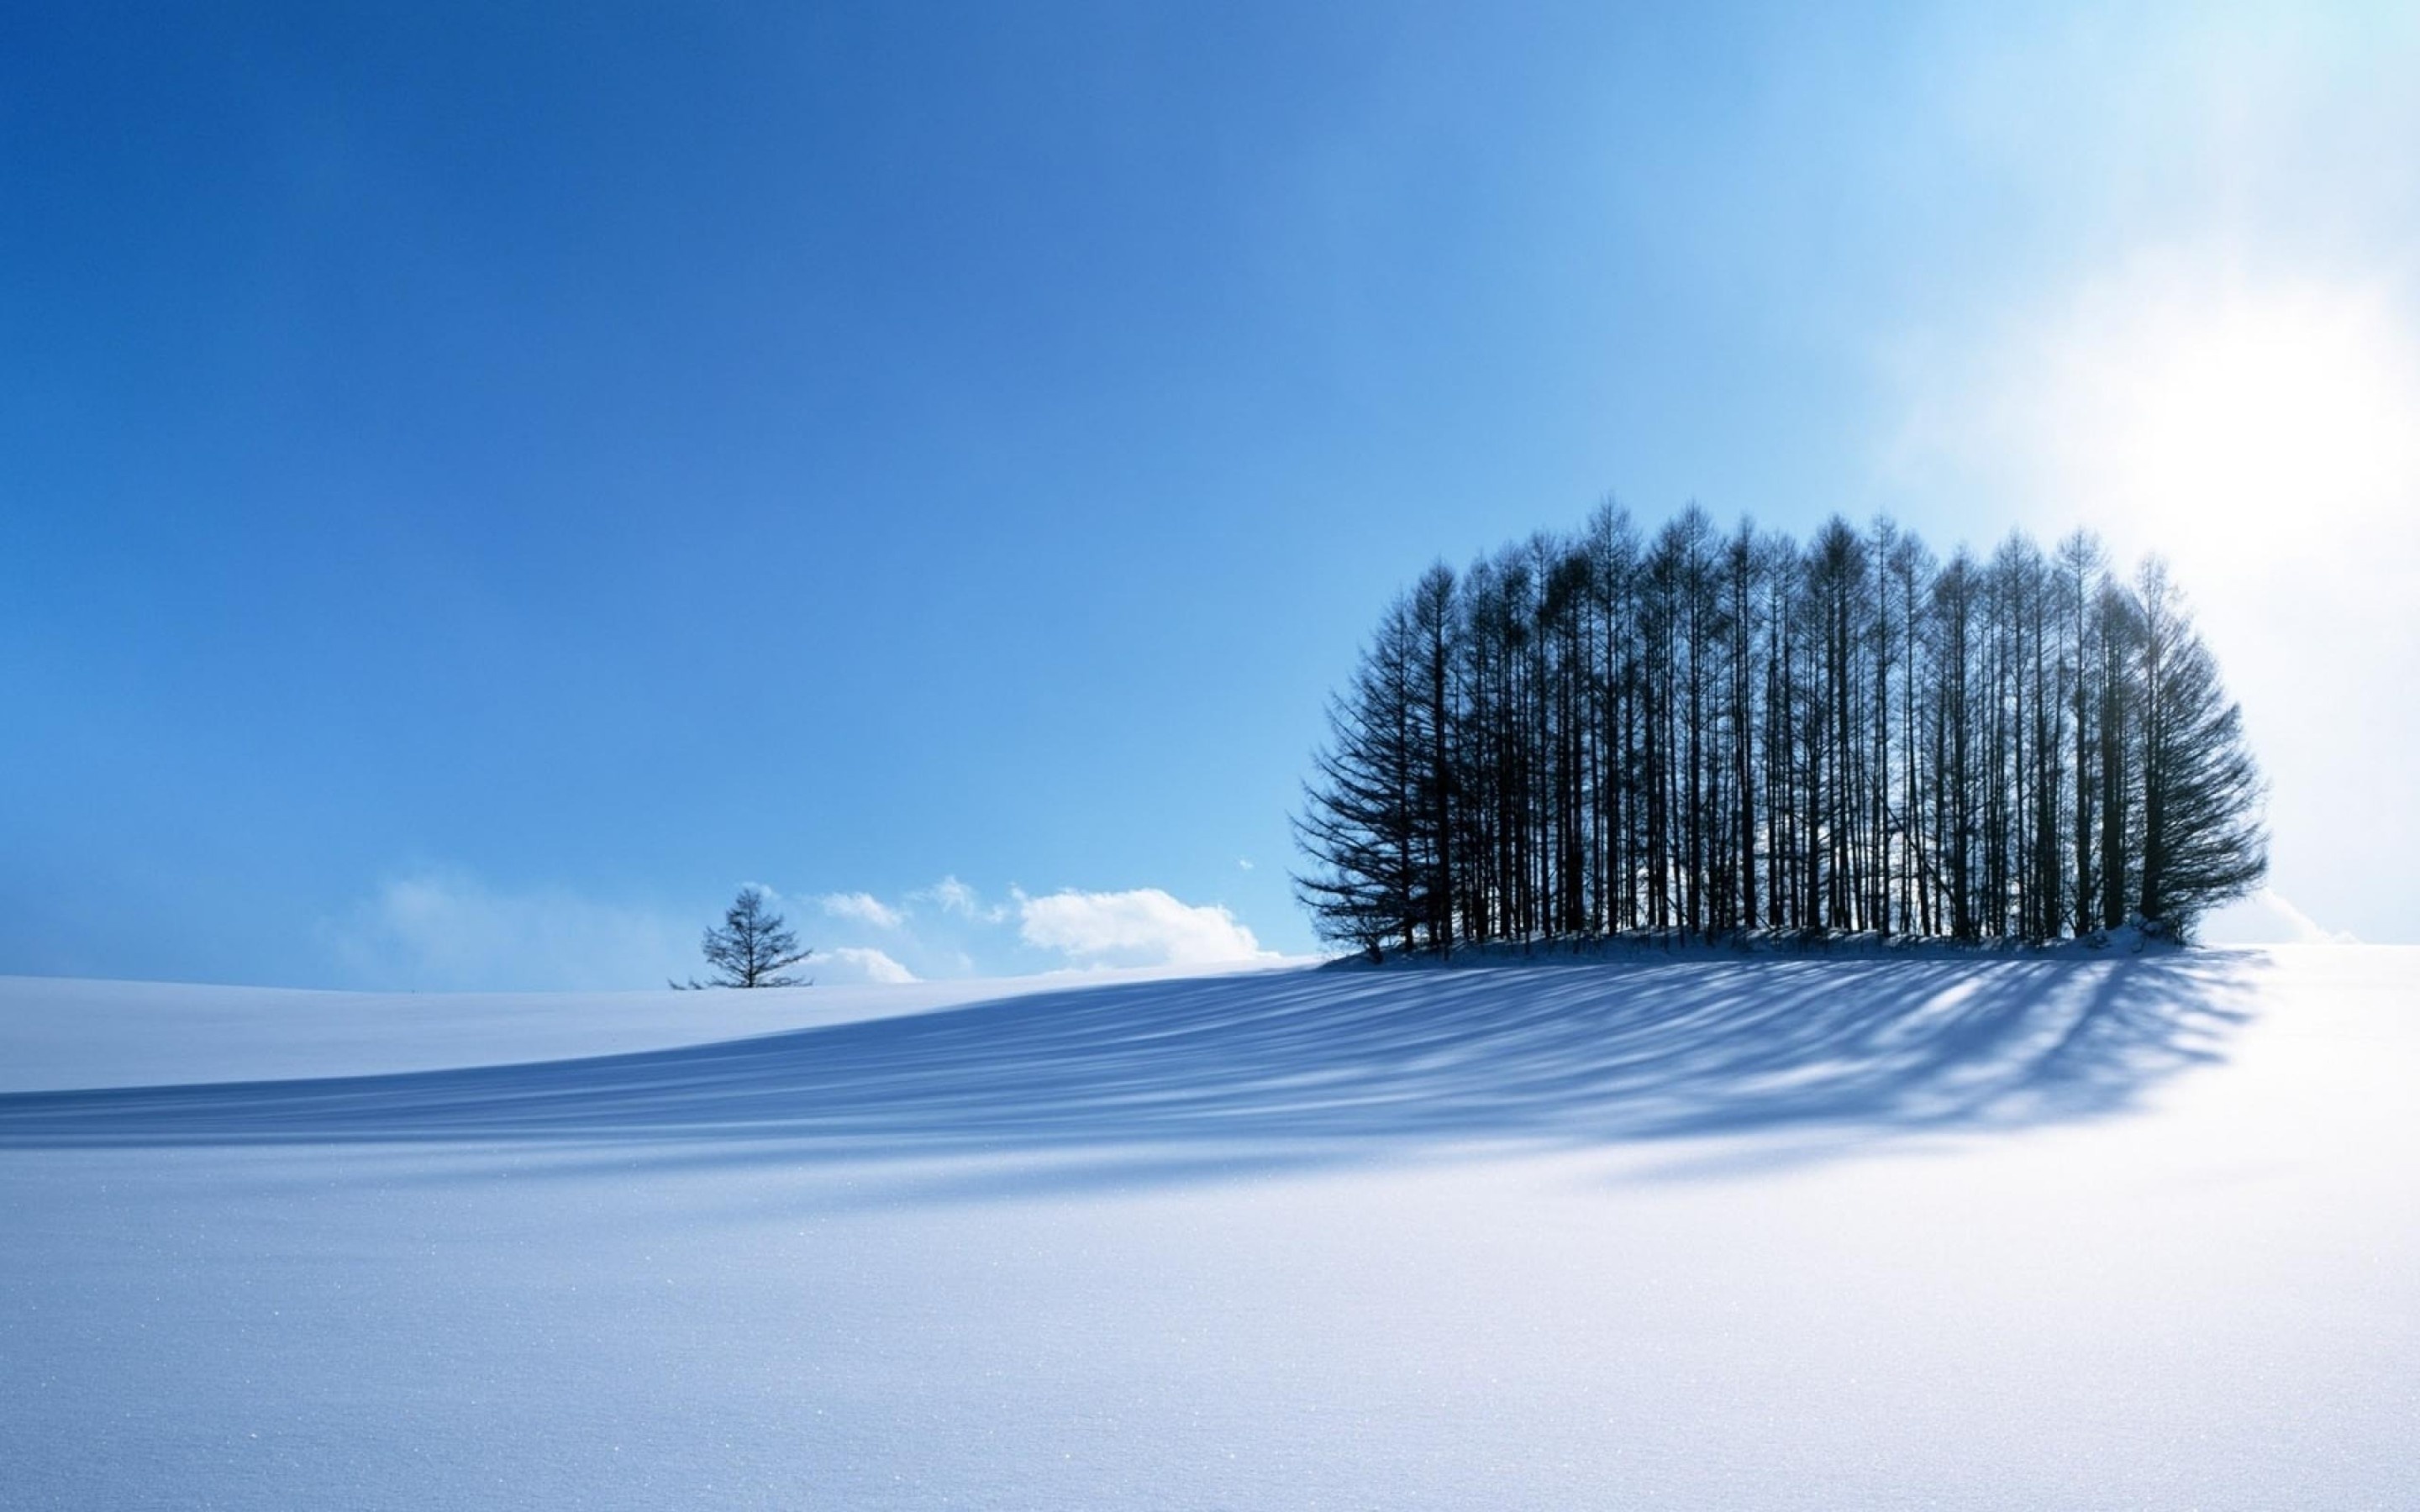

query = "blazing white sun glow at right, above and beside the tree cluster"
[[1890, 244, 2420, 938]]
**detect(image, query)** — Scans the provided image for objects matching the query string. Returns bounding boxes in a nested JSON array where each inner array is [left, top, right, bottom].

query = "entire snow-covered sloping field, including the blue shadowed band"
[[0, 946, 2420, 1507]]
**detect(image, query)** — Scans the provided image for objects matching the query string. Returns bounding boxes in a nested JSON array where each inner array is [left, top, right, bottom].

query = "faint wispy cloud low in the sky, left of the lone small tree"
[[322, 871, 699, 992]]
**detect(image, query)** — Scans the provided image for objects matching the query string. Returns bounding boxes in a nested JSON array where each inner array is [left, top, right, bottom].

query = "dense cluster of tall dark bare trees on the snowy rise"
[[1295, 503, 2268, 953]]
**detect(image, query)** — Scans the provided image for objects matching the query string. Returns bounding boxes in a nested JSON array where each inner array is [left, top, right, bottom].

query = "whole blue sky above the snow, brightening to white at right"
[[0, 5, 2420, 987]]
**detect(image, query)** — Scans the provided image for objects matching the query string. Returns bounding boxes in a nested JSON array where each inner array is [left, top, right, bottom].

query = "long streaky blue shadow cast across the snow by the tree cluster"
[[0, 953, 2250, 1183]]
